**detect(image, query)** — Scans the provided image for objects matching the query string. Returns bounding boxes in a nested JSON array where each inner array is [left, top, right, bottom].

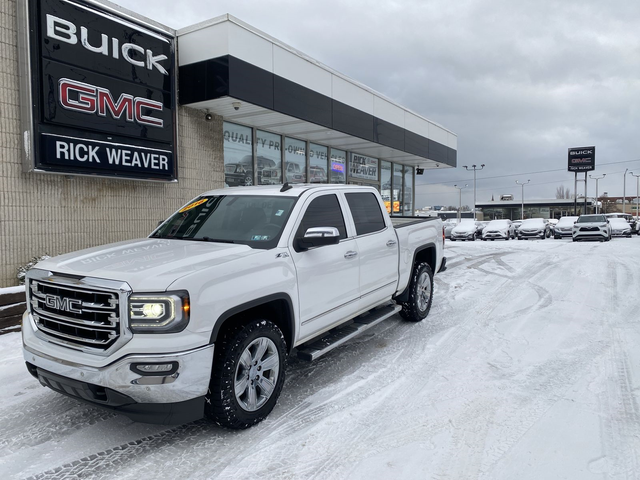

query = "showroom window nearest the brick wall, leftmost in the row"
[[223, 122, 253, 187]]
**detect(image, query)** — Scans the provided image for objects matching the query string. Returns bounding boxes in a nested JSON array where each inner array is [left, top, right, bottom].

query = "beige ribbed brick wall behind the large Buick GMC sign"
[[0, 0, 224, 287]]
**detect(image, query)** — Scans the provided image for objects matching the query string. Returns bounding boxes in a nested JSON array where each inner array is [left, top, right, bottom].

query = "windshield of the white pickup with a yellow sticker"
[[150, 195, 297, 249]]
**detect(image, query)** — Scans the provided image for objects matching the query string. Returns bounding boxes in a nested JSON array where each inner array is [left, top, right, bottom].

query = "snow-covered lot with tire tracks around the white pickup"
[[0, 237, 640, 480]]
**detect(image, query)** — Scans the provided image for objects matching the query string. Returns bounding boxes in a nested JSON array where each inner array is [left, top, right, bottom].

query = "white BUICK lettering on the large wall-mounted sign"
[[47, 13, 169, 75]]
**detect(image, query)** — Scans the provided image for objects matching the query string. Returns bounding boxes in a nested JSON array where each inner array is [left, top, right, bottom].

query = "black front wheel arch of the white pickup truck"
[[210, 293, 295, 353]]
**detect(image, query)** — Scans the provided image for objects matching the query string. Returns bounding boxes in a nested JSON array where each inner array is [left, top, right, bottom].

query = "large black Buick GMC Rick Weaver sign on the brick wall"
[[19, 0, 177, 180]]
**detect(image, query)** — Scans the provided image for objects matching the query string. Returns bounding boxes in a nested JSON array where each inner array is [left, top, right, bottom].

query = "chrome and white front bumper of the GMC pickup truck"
[[23, 313, 214, 424]]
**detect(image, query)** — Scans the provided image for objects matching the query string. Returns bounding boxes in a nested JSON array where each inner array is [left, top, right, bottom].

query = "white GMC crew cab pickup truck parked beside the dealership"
[[22, 184, 446, 428]]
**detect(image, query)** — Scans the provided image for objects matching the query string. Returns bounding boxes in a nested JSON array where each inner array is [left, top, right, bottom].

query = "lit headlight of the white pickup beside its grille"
[[129, 292, 189, 333]]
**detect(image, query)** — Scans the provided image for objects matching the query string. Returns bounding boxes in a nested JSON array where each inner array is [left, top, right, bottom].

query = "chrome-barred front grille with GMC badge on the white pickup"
[[29, 279, 120, 350]]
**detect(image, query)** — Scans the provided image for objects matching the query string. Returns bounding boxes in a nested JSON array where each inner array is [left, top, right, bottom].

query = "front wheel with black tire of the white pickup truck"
[[205, 320, 287, 429]]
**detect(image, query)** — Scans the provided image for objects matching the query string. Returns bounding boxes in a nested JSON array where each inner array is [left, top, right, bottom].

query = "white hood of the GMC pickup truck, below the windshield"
[[35, 238, 260, 291]]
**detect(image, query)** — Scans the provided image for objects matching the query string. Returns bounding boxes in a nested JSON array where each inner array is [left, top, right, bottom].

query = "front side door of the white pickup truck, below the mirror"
[[290, 193, 360, 341]]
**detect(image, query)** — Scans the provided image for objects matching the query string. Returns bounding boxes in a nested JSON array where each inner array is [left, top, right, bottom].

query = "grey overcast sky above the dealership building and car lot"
[[115, 0, 640, 207]]
